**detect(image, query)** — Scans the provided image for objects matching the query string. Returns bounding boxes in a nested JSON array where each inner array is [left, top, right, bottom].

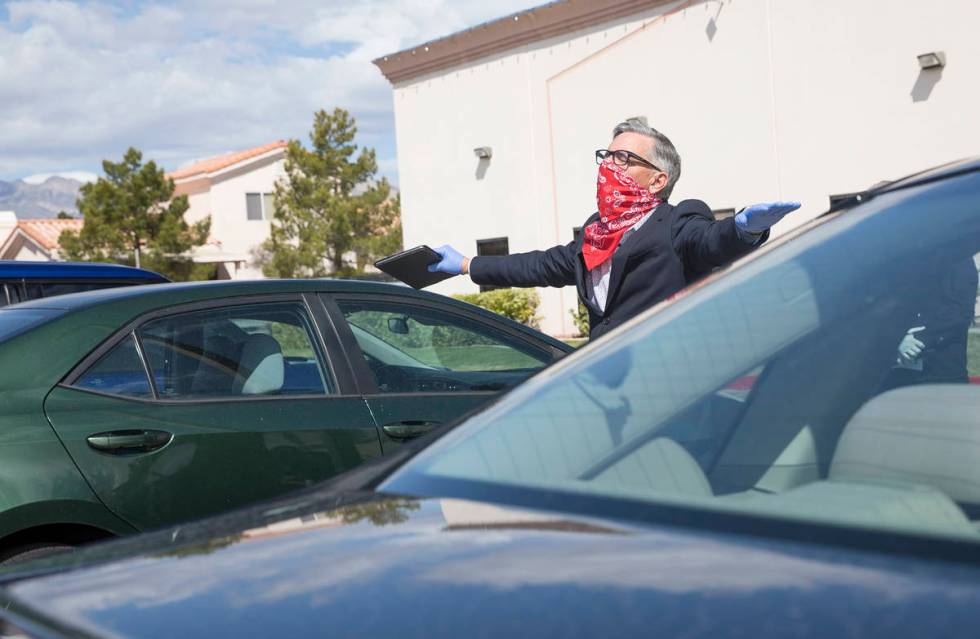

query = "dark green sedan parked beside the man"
[[0, 280, 570, 561]]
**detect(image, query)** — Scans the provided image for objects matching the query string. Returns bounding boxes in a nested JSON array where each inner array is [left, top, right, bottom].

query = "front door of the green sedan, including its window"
[[322, 294, 564, 451]]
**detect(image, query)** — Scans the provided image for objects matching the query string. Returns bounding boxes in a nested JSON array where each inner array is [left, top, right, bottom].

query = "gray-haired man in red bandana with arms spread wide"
[[429, 119, 800, 339]]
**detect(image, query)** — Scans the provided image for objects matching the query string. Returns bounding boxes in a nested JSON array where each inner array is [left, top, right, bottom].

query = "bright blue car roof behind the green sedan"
[[0, 260, 170, 306]]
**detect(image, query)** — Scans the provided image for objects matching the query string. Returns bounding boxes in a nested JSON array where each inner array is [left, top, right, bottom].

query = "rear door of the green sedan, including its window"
[[45, 295, 381, 530]]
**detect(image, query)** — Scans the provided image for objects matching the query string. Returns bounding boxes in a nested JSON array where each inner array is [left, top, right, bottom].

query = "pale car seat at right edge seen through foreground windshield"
[[829, 384, 980, 504]]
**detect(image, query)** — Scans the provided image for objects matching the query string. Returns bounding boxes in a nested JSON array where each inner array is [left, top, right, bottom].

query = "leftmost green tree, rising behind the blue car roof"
[[58, 148, 214, 280]]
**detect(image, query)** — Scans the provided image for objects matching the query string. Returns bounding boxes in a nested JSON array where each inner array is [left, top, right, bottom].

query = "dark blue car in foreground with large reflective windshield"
[[0, 161, 980, 639]]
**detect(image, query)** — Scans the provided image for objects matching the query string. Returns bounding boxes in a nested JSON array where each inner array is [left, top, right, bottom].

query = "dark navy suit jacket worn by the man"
[[470, 200, 769, 339]]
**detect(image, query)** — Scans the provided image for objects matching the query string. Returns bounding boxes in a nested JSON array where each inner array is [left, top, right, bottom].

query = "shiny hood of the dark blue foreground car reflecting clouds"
[[3, 498, 980, 639]]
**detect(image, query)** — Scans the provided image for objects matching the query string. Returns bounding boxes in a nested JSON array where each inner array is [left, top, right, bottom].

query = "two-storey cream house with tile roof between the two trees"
[[168, 140, 286, 279]]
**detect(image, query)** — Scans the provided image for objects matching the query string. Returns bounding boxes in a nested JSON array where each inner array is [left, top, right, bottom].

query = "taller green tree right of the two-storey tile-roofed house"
[[259, 109, 401, 277]]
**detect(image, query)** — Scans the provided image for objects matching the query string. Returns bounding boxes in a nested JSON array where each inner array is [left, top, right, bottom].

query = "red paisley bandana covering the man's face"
[[582, 160, 662, 271]]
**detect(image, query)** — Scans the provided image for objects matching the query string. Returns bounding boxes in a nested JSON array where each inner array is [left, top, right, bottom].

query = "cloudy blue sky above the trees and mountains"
[[0, 0, 541, 183]]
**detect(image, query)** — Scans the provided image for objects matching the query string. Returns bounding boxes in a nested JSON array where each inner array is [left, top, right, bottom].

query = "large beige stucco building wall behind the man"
[[394, 0, 980, 334]]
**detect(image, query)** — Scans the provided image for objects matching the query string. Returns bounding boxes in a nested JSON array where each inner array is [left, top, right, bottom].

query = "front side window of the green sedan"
[[338, 300, 554, 393]]
